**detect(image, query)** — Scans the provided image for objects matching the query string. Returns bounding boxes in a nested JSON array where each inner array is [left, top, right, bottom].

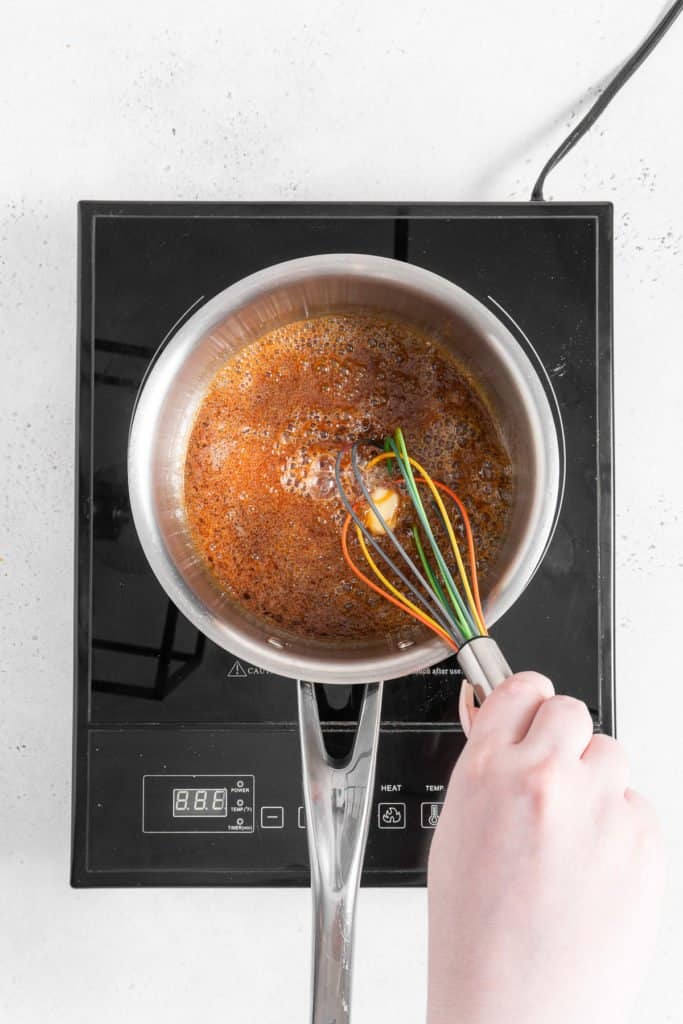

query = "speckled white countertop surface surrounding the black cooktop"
[[0, 0, 683, 1024]]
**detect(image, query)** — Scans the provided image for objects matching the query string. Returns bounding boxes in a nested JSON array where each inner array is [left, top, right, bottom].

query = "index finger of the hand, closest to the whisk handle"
[[470, 672, 555, 743]]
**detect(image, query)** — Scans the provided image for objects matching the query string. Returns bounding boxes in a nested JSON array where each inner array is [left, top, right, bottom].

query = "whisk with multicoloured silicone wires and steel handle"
[[335, 427, 512, 716]]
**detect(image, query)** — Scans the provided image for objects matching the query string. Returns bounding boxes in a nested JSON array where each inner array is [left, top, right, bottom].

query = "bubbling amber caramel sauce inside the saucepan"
[[184, 313, 512, 643]]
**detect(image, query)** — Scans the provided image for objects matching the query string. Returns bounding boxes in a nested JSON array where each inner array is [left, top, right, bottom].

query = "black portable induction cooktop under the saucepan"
[[72, 203, 614, 886]]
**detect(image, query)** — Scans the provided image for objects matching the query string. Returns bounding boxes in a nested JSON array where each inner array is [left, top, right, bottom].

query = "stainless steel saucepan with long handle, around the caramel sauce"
[[128, 254, 560, 1024]]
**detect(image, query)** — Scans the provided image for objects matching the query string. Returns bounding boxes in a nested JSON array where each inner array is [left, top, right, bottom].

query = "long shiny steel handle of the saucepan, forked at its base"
[[299, 682, 382, 1024]]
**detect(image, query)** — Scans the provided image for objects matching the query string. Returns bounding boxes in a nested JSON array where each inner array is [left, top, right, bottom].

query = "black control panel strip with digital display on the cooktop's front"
[[87, 729, 464, 885]]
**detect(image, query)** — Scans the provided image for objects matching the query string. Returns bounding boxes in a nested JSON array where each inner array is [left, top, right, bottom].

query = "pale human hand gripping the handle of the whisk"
[[428, 672, 664, 1024]]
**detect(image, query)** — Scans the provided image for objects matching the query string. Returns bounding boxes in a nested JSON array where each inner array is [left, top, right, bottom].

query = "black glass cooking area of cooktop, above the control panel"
[[84, 201, 603, 724]]
